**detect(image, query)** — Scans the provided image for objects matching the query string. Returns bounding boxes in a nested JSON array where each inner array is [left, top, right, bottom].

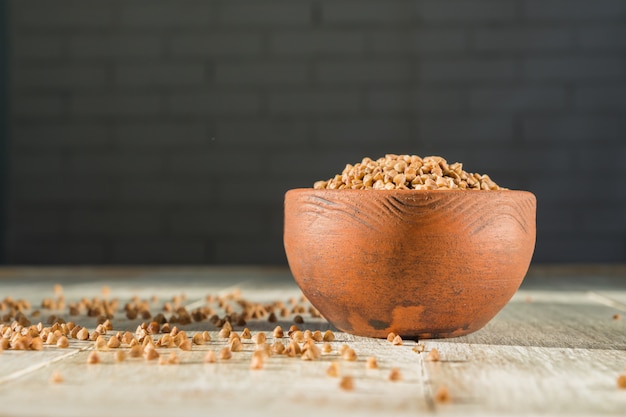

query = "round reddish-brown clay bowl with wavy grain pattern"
[[284, 189, 536, 338]]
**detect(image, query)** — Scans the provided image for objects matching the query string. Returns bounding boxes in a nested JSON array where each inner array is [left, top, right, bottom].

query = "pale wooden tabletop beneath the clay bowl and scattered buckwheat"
[[0, 267, 626, 417]]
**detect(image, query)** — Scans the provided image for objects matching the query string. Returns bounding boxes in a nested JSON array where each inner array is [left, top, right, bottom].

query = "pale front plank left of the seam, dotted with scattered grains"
[[0, 334, 428, 416]]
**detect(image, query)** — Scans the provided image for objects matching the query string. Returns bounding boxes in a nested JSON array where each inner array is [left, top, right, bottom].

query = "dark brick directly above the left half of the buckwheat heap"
[[316, 119, 411, 146]]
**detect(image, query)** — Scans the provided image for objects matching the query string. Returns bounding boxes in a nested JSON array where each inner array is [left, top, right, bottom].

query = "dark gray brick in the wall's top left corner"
[[11, 1, 113, 29]]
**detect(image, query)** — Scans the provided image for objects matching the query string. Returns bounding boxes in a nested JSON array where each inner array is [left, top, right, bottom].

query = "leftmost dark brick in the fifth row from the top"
[[11, 122, 110, 150]]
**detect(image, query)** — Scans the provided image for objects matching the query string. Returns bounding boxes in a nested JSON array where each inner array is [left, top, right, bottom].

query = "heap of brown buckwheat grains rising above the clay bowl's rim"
[[313, 154, 505, 190]]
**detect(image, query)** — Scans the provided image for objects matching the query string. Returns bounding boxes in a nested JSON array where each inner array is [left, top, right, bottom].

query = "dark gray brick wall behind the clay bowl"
[[6, 0, 626, 263]]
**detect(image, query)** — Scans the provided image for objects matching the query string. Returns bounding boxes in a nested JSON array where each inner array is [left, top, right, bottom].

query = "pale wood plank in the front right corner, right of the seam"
[[420, 341, 626, 415]]
